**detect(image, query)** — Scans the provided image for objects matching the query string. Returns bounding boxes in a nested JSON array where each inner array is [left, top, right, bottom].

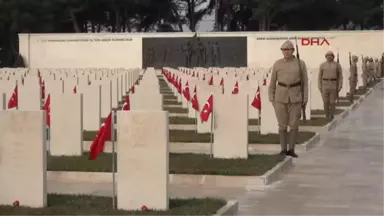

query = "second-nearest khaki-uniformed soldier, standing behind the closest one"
[[318, 51, 343, 119]]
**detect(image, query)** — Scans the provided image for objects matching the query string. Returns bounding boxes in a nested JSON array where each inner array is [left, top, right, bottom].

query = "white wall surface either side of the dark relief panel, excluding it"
[[19, 31, 384, 68]]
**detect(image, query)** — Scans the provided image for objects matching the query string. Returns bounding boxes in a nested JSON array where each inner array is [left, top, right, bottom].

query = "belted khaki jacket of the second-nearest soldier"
[[318, 61, 343, 91]]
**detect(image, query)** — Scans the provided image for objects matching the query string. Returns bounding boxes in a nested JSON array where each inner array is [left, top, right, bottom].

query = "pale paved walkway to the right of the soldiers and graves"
[[239, 82, 384, 216]]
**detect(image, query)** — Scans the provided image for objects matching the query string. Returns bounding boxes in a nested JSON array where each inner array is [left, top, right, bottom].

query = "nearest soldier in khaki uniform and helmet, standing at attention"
[[268, 41, 308, 157]]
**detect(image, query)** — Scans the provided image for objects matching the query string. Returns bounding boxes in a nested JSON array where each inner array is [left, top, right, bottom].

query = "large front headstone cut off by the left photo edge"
[[0, 111, 47, 208]]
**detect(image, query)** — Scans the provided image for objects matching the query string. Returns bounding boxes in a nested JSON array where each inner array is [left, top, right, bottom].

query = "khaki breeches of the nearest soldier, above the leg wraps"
[[273, 102, 302, 131]]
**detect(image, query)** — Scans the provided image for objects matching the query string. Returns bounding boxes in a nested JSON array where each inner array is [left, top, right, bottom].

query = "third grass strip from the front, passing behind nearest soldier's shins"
[[83, 130, 316, 144]]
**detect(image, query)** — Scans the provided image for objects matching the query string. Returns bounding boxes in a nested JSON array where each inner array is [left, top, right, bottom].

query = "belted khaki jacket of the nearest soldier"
[[268, 57, 308, 103]]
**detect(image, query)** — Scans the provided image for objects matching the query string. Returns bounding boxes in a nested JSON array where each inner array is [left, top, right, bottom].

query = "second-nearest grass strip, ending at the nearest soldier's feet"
[[47, 153, 284, 176]]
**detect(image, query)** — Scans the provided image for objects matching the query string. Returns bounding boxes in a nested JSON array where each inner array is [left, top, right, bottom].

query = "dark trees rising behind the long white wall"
[[0, 0, 384, 67]]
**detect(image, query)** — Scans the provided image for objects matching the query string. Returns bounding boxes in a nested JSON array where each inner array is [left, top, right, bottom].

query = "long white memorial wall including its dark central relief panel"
[[19, 31, 384, 68]]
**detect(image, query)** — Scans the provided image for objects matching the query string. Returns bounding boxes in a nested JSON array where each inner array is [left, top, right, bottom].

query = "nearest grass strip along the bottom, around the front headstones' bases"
[[0, 194, 226, 216]]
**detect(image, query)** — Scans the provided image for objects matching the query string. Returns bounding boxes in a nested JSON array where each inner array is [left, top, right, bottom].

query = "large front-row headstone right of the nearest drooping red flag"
[[117, 111, 169, 210]]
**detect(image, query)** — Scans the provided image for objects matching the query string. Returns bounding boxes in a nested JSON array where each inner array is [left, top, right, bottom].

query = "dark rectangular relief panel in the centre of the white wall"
[[142, 37, 247, 68]]
